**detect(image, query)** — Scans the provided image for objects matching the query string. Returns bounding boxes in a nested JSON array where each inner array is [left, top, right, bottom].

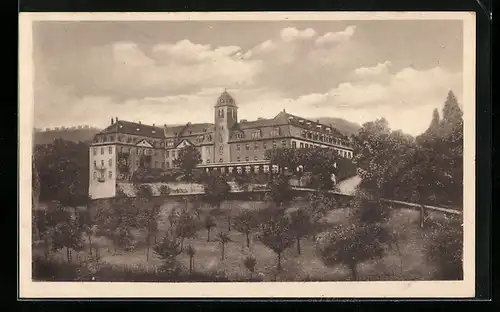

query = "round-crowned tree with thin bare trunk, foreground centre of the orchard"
[[260, 215, 294, 273]]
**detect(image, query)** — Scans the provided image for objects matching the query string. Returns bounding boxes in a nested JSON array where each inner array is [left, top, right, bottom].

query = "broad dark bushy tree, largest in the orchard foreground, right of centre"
[[318, 191, 393, 280]]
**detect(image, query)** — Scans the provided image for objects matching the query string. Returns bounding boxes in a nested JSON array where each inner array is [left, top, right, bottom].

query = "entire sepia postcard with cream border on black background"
[[19, 12, 475, 298]]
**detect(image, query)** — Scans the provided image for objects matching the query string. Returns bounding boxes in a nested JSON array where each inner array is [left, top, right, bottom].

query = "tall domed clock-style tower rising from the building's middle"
[[214, 90, 238, 162]]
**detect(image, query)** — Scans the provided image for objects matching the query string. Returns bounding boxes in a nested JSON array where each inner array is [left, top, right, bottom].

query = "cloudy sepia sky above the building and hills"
[[33, 20, 463, 135]]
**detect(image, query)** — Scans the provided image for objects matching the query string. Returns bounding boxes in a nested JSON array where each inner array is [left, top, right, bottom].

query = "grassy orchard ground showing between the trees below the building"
[[35, 200, 460, 281]]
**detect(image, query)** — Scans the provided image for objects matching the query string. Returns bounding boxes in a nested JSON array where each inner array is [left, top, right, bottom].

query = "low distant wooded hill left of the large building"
[[34, 127, 101, 144]]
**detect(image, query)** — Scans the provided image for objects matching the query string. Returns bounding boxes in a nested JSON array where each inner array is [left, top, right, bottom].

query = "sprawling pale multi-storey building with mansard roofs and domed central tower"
[[89, 91, 353, 198]]
